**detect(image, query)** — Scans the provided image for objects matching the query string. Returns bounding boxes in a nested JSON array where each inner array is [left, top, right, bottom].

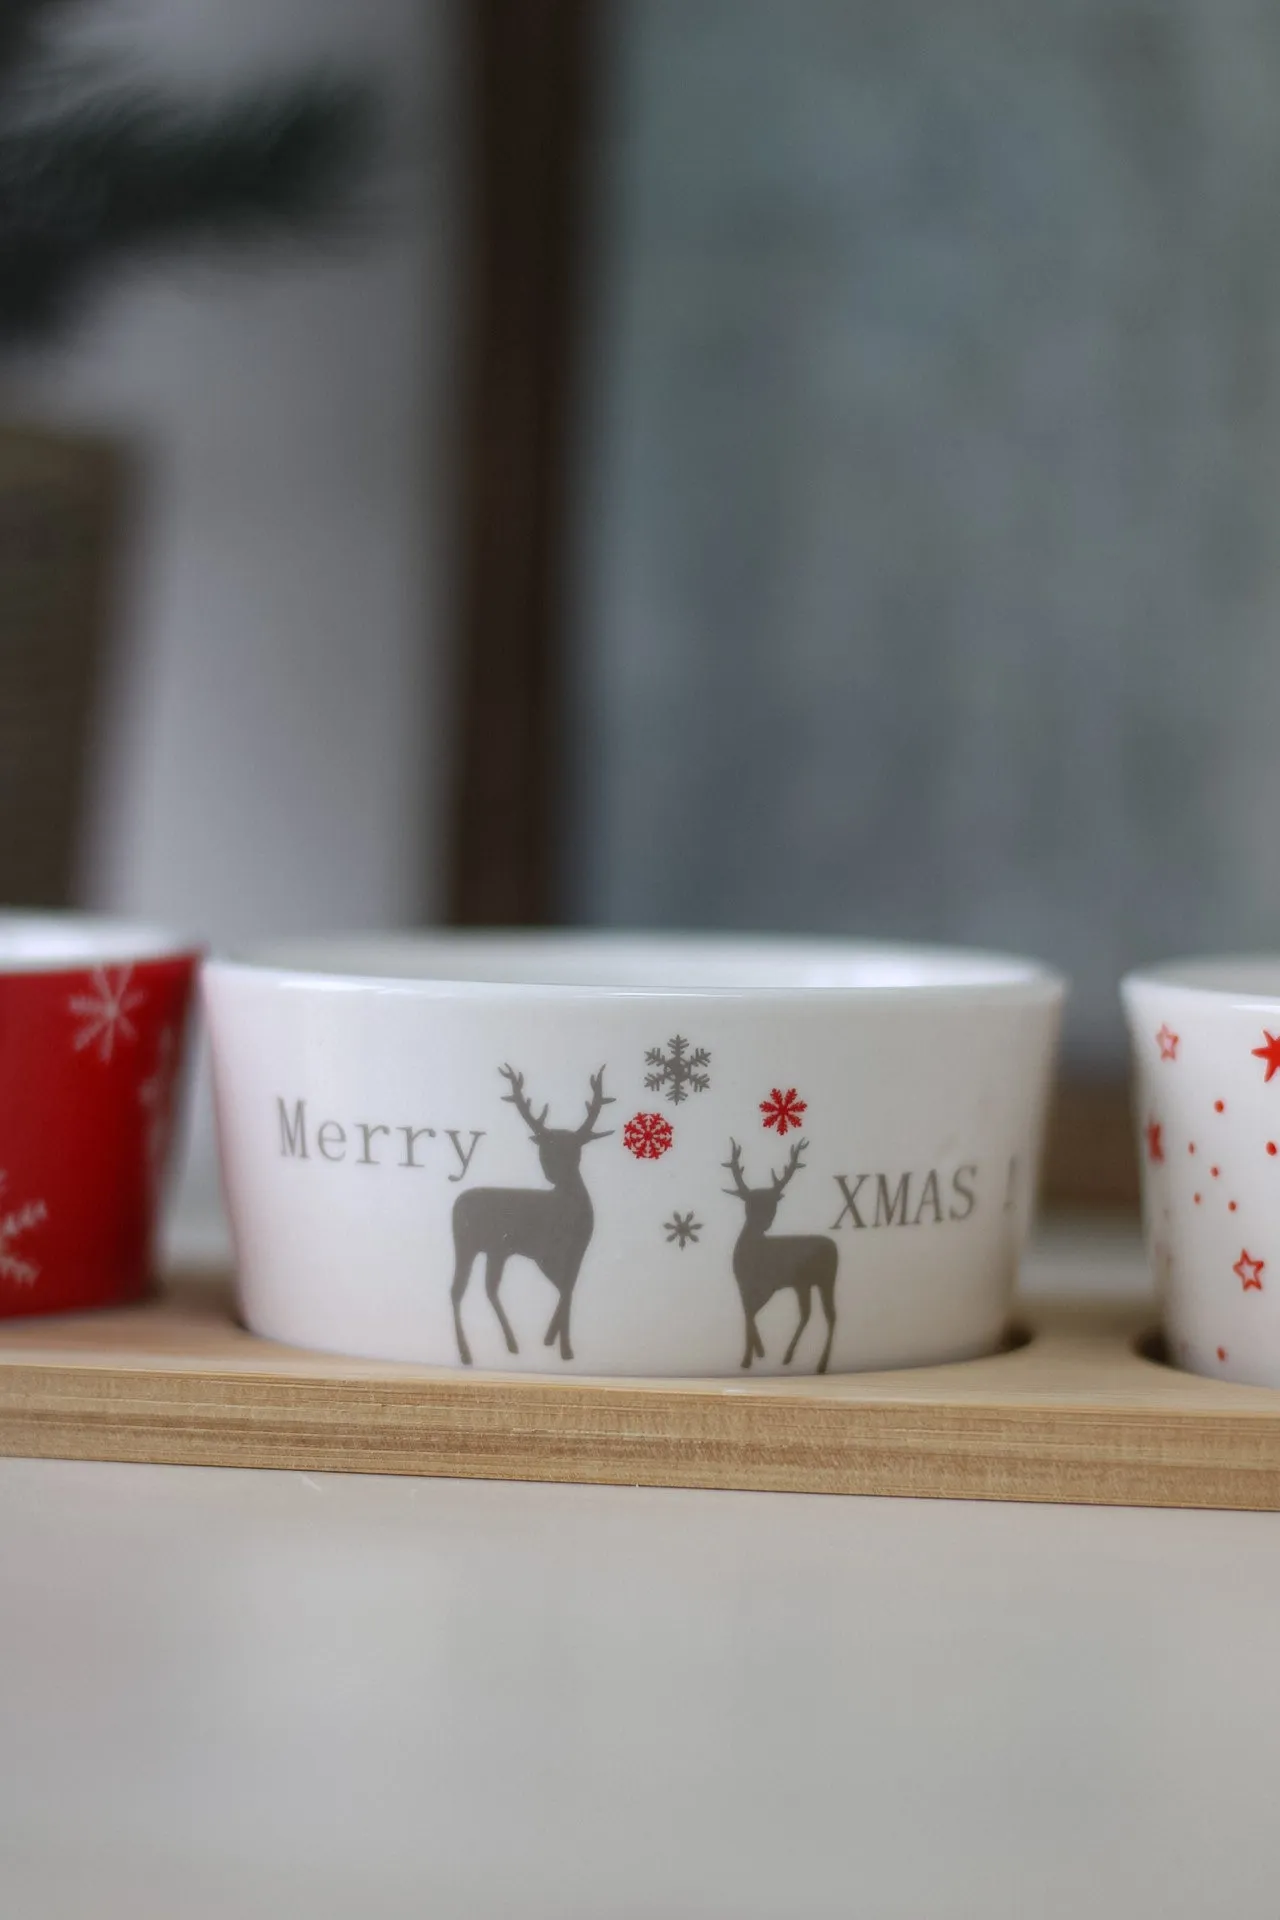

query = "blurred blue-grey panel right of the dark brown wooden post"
[[566, 0, 1280, 1069]]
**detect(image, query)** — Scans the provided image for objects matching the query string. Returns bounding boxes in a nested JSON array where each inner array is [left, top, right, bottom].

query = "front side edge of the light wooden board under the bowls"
[[0, 1367, 1280, 1511]]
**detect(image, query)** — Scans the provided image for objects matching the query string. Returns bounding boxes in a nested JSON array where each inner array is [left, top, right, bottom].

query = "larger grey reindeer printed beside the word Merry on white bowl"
[[453, 1068, 614, 1367]]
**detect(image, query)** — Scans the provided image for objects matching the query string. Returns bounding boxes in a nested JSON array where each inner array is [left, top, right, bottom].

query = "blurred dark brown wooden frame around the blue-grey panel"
[[447, 0, 1138, 1206]]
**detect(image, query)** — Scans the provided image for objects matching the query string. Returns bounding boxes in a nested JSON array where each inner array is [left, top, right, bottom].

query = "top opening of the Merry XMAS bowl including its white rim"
[[205, 927, 1067, 1006]]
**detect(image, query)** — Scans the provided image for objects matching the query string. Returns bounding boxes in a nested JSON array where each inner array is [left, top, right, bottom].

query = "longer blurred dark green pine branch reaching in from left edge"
[[0, 81, 374, 344]]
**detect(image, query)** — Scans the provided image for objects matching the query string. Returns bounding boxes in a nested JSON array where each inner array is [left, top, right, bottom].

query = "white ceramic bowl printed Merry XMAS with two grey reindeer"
[[205, 935, 1063, 1375]]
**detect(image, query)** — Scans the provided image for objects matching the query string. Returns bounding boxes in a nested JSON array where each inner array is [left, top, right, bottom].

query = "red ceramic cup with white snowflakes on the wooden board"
[[0, 912, 200, 1317]]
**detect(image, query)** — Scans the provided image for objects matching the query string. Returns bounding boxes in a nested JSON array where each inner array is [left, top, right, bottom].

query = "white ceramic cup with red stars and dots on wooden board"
[[1121, 958, 1280, 1386]]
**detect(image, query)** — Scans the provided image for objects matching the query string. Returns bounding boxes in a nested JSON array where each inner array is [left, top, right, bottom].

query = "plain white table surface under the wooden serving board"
[[0, 1242, 1280, 1920]]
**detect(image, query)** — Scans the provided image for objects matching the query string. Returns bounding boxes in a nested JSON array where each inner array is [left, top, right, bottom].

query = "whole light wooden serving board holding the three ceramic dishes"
[[0, 1279, 1280, 1511]]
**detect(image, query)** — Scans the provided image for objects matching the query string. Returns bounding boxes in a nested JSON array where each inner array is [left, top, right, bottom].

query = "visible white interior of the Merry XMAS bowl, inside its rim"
[[232, 933, 1061, 998]]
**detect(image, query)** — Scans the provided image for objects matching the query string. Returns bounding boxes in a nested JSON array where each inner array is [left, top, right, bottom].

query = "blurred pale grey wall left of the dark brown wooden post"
[[0, 0, 457, 1252]]
